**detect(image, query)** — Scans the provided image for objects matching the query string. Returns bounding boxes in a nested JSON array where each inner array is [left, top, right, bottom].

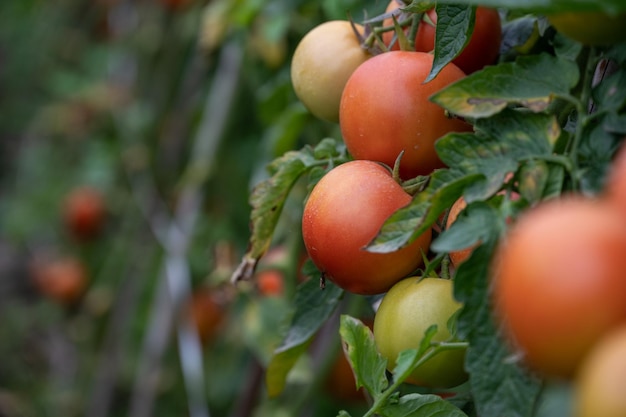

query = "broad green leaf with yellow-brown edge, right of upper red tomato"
[[431, 54, 579, 118]]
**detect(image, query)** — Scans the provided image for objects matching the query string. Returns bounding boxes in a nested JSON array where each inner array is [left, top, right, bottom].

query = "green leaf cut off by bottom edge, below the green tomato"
[[372, 394, 467, 417]]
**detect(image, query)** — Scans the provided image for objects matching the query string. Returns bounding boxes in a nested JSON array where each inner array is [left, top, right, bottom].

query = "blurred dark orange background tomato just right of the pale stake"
[[187, 288, 226, 344]]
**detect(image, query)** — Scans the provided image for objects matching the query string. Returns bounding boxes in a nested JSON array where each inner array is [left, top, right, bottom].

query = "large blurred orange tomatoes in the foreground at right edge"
[[492, 147, 626, 416]]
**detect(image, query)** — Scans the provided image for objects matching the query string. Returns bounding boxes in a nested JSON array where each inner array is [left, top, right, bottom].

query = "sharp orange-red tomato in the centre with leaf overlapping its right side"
[[302, 160, 431, 294]]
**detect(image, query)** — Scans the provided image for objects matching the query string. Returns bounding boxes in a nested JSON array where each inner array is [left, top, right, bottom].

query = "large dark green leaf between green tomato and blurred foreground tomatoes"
[[454, 239, 541, 417]]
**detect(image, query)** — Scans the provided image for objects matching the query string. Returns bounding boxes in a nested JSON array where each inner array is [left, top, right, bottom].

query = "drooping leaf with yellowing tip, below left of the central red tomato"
[[265, 279, 343, 397]]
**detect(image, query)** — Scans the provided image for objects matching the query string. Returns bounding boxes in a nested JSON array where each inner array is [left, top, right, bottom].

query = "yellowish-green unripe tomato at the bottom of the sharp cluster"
[[374, 277, 467, 388]]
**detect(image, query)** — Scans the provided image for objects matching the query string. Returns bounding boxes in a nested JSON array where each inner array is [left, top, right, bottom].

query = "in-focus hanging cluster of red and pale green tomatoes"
[[291, 0, 501, 388]]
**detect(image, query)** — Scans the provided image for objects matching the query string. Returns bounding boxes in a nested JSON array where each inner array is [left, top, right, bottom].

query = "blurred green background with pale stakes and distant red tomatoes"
[[0, 0, 380, 417]]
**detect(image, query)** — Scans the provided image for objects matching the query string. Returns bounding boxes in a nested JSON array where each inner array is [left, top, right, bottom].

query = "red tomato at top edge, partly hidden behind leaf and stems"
[[383, 0, 502, 74]]
